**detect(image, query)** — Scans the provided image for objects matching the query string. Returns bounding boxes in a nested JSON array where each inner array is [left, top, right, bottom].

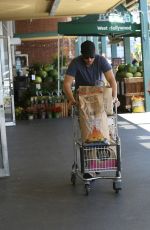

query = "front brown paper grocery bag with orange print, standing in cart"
[[79, 86, 109, 142]]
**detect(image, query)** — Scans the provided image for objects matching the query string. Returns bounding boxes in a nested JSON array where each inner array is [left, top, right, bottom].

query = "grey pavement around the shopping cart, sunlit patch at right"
[[0, 113, 150, 230]]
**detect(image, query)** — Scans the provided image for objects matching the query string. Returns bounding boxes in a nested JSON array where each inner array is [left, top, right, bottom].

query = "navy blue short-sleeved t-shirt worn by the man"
[[66, 55, 111, 89]]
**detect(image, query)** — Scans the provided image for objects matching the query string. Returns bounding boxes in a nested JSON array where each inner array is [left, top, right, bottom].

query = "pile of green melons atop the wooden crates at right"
[[116, 62, 143, 81]]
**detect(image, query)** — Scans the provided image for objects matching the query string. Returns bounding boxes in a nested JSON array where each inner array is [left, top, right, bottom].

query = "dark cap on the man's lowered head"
[[81, 40, 95, 58]]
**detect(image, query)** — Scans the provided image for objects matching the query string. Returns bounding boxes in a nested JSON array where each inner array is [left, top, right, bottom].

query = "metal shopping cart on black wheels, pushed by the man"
[[71, 105, 122, 195]]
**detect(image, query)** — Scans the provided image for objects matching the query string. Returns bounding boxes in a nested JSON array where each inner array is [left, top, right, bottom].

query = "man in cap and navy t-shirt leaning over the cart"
[[63, 40, 117, 108]]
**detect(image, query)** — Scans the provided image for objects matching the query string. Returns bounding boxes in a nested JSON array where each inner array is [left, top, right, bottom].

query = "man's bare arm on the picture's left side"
[[63, 75, 76, 107]]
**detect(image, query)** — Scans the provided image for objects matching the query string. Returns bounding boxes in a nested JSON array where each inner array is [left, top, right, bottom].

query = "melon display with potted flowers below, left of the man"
[[15, 58, 67, 119]]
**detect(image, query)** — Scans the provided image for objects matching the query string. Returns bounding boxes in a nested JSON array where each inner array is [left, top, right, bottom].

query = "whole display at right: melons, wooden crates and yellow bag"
[[116, 62, 144, 112]]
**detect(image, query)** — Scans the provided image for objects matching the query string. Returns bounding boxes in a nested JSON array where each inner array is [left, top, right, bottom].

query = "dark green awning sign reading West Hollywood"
[[58, 14, 141, 37]]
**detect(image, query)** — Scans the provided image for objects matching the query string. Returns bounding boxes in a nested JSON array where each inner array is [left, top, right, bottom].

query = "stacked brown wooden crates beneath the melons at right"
[[117, 77, 144, 112]]
